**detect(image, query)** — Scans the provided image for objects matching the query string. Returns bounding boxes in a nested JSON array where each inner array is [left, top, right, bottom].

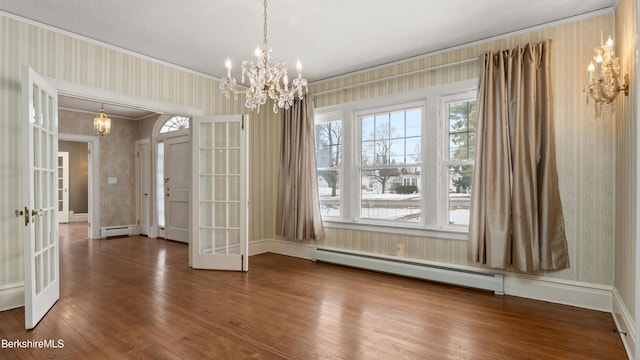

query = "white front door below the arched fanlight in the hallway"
[[164, 135, 191, 242]]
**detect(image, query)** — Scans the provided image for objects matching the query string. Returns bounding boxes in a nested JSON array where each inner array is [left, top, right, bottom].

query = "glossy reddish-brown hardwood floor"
[[0, 225, 626, 360]]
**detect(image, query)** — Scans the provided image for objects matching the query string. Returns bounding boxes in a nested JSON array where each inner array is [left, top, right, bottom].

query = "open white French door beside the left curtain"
[[190, 115, 249, 271]]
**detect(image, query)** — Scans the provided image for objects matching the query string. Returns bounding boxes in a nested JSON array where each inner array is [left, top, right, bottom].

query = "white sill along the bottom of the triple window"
[[322, 220, 469, 241]]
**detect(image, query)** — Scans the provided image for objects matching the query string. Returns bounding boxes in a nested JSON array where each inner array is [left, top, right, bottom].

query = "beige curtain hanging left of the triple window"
[[276, 94, 324, 240]]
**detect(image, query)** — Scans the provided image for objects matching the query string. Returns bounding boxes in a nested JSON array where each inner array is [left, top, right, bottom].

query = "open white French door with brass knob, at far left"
[[22, 66, 60, 329]]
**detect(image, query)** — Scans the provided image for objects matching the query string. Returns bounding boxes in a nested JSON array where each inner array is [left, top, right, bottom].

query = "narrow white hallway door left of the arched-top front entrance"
[[136, 139, 151, 235]]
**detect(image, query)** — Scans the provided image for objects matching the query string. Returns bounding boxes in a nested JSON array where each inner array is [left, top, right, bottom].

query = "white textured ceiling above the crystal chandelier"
[[0, 0, 617, 115]]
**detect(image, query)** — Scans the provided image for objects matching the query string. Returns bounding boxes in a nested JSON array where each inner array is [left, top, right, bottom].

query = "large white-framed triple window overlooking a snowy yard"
[[315, 80, 477, 239]]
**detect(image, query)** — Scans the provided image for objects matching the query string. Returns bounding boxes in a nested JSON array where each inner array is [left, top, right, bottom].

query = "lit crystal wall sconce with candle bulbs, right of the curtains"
[[583, 37, 629, 118]]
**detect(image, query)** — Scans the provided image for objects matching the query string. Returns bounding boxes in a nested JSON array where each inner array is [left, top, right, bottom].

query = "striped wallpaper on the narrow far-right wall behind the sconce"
[[615, 0, 640, 320]]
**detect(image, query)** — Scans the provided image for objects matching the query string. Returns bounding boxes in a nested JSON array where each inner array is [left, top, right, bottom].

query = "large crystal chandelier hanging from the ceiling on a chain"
[[220, 0, 308, 113]]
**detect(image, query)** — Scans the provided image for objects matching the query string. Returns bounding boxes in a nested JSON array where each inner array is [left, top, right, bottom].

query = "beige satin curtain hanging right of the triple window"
[[468, 40, 569, 272]]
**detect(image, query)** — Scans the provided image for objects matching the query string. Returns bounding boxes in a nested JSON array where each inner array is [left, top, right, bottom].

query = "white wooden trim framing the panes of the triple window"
[[315, 79, 478, 240]]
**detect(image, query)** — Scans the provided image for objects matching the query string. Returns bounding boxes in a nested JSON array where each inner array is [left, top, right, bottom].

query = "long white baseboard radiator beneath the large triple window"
[[312, 248, 504, 295]]
